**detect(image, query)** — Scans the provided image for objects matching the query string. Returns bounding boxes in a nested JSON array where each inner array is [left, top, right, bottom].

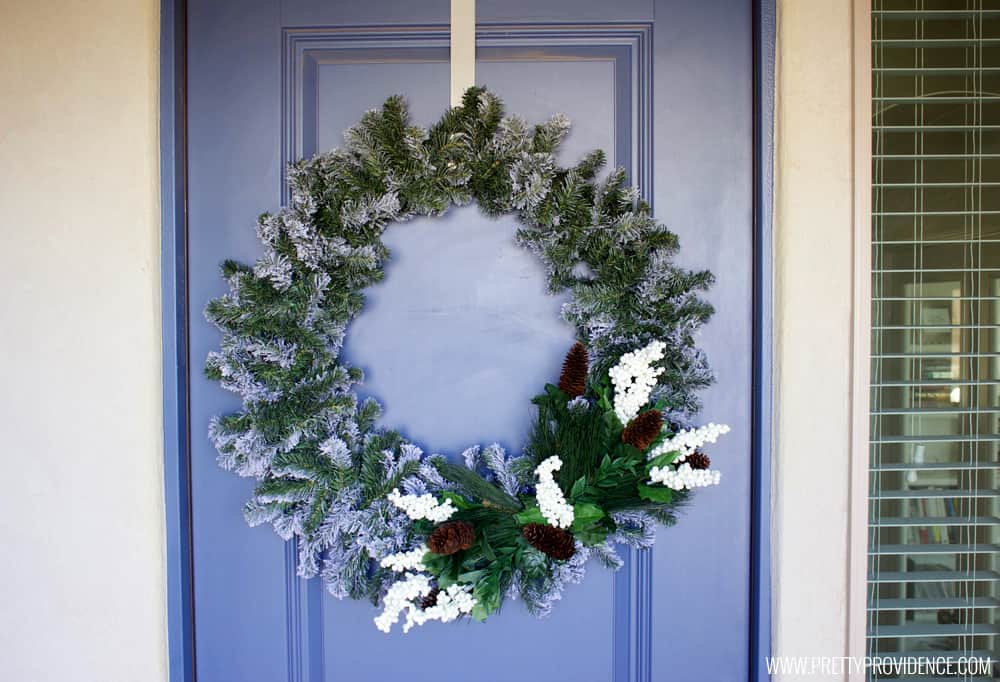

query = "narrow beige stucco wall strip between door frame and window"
[[772, 0, 864, 680]]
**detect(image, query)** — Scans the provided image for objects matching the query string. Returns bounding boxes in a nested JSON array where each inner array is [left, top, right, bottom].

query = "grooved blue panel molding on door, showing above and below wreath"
[[278, 23, 655, 682]]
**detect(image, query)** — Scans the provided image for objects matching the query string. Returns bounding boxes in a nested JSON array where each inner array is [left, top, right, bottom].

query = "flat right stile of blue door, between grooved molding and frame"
[[639, 0, 754, 682]]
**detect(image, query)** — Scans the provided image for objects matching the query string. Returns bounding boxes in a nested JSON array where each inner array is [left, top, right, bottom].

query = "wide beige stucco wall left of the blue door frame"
[[0, 0, 166, 682]]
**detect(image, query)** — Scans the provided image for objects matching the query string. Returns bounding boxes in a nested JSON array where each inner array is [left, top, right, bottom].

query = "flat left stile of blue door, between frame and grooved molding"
[[188, 0, 294, 682]]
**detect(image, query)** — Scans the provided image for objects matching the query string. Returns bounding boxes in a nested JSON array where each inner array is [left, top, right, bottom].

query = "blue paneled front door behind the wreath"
[[188, 0, 753, 682]]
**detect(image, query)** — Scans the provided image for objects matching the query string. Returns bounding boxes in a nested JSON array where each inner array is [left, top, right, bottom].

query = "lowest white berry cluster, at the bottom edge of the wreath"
[[375, 573, 476, 633]]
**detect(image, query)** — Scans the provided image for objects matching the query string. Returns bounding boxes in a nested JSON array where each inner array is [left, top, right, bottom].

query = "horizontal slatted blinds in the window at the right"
[[868, 0, 1000, 680]]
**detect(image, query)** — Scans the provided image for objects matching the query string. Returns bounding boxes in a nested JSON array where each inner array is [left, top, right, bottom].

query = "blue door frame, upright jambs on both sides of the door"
[[159, 0, 775, 682]]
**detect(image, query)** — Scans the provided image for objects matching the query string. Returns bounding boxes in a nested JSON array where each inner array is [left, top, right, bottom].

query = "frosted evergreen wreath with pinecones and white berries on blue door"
[[206, 88, 728, 632]]
